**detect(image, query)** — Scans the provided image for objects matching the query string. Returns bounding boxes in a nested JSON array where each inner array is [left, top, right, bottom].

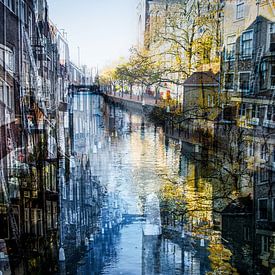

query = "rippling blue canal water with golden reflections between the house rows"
[[69, 95, 224, 275]]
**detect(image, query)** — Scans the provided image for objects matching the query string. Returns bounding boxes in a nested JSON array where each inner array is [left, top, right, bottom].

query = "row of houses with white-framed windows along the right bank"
[[138, 0, 275, 274]]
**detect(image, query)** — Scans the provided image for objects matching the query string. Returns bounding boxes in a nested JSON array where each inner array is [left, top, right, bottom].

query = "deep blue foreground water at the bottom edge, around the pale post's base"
[[76, 216, 209, 275]]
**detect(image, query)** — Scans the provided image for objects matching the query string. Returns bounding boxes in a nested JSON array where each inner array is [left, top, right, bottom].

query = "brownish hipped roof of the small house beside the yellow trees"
[[183, 70, 219, 86]]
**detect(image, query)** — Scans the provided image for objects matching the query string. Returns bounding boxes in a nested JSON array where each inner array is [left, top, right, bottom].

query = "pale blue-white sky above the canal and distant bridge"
[[48, 0, 138, 69]]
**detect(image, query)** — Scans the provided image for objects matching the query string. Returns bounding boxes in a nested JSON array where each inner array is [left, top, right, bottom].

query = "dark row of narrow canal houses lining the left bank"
[[0, 0, 100, 274]]
